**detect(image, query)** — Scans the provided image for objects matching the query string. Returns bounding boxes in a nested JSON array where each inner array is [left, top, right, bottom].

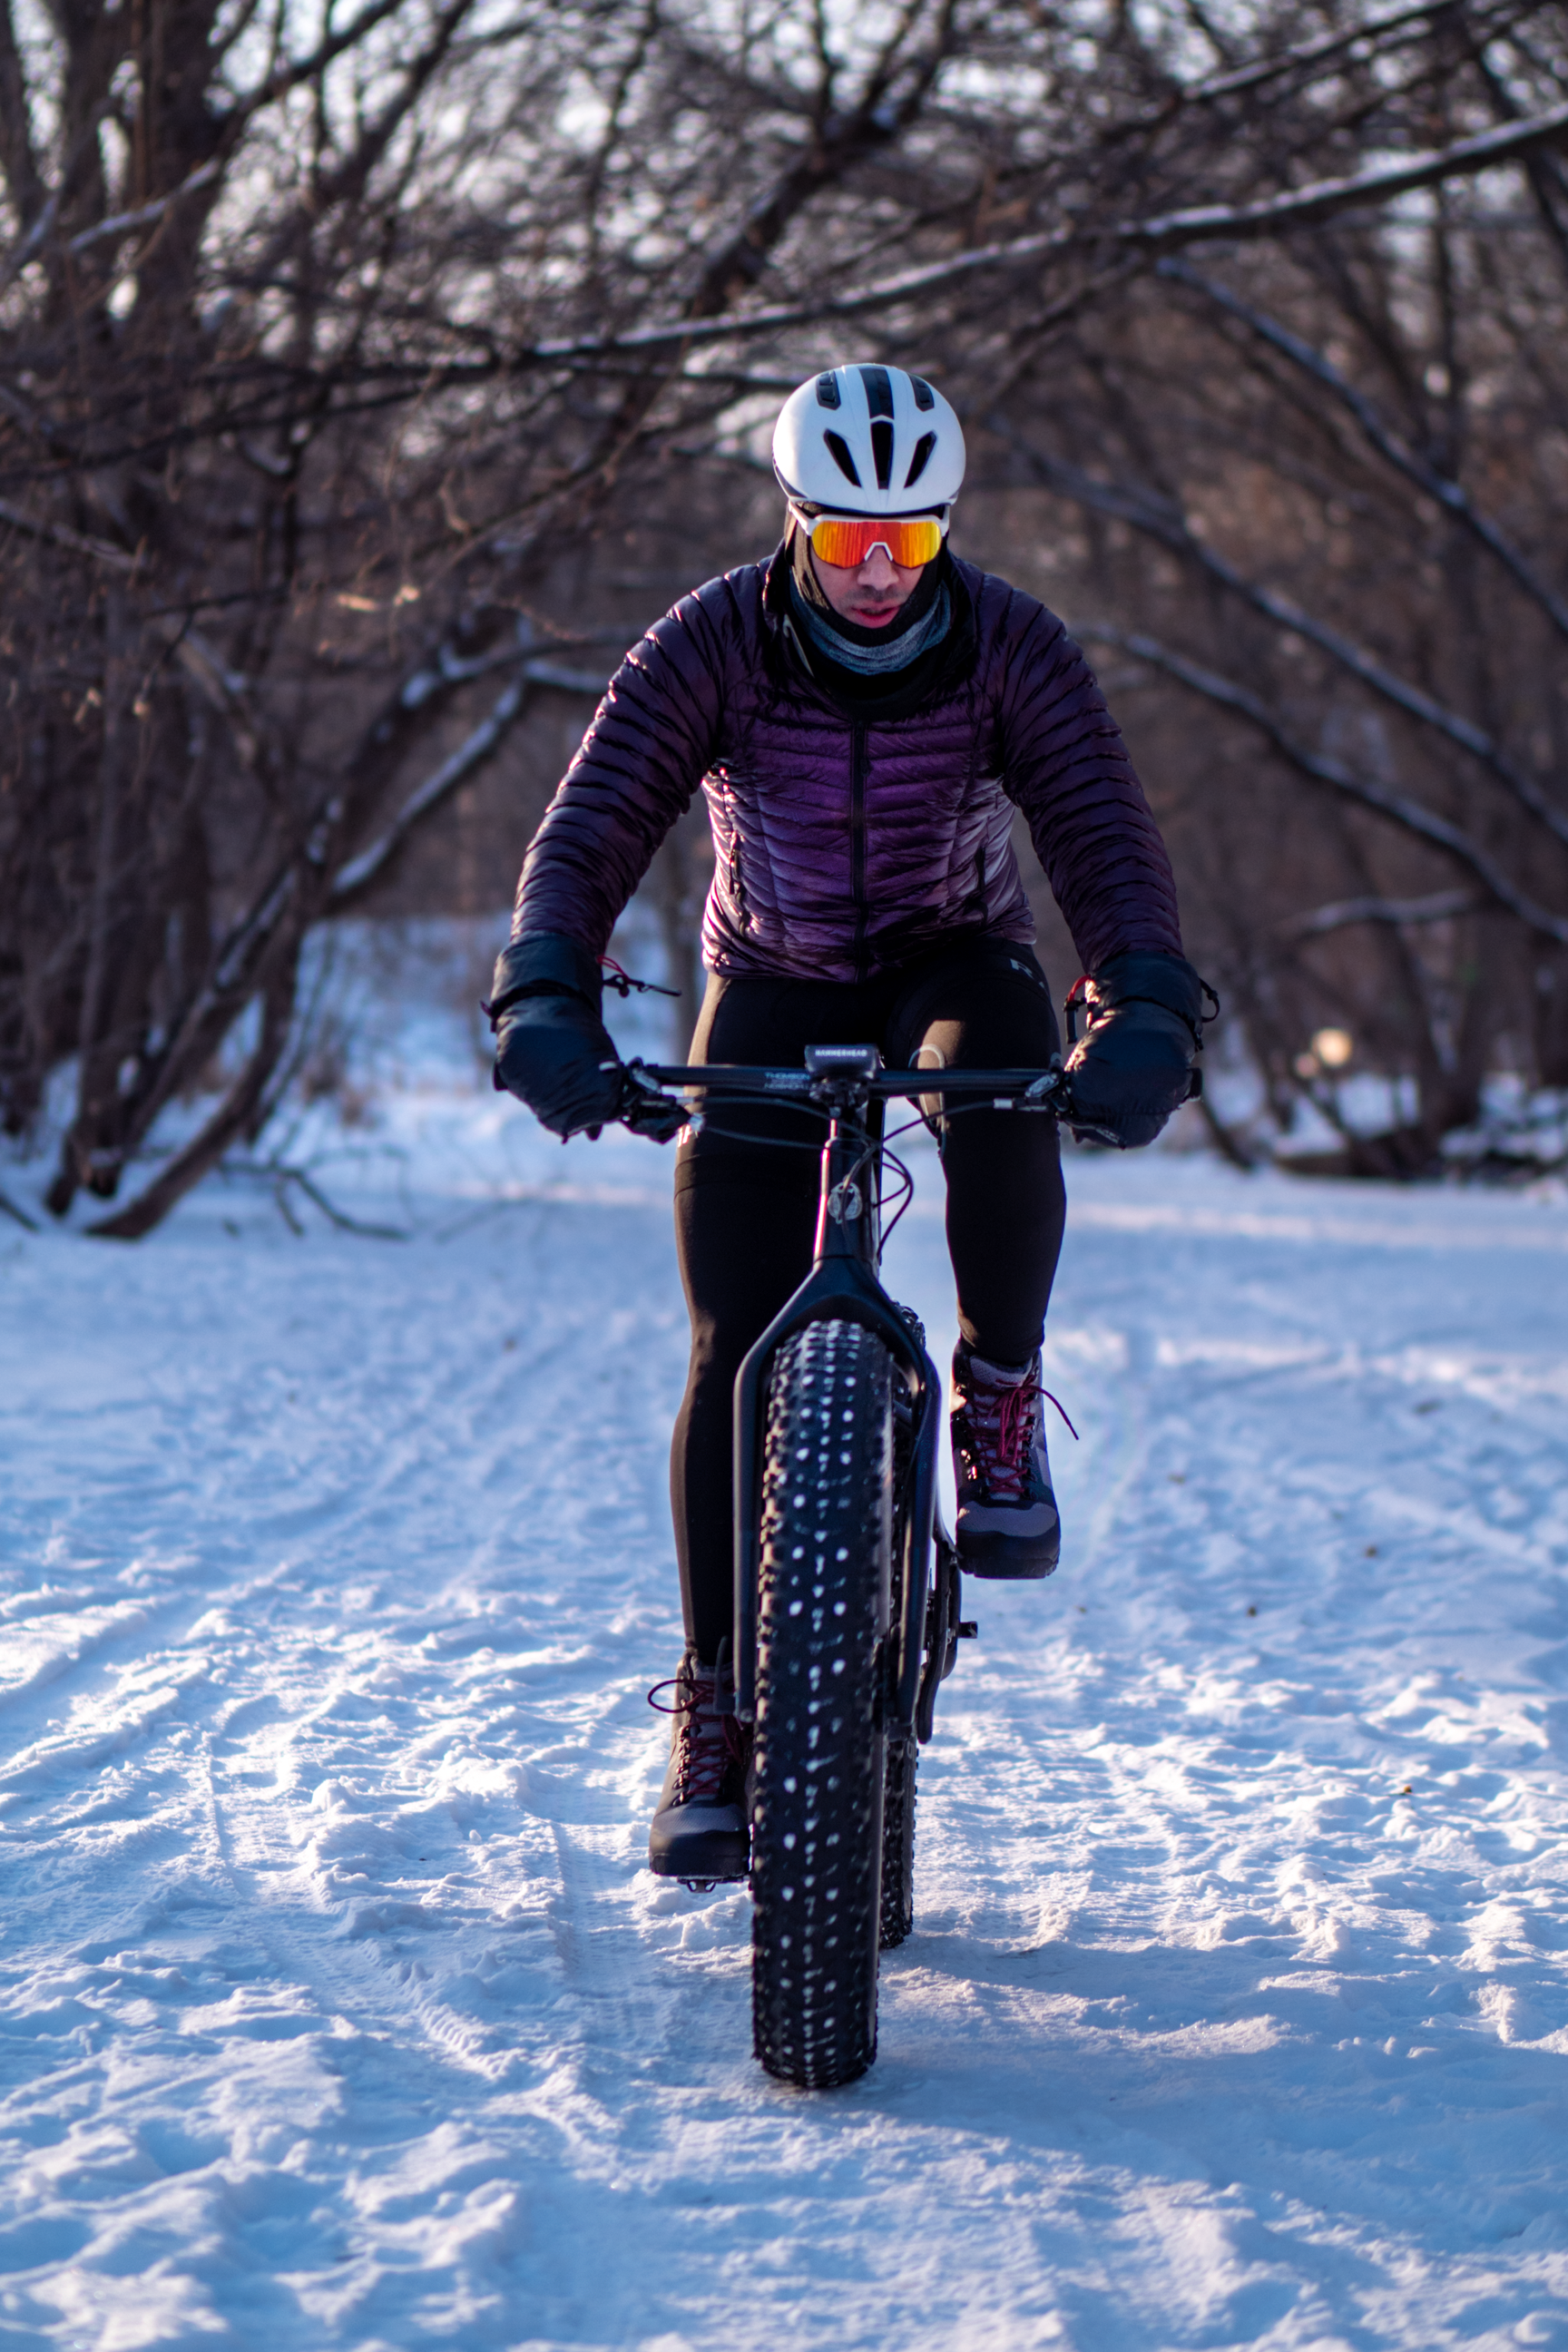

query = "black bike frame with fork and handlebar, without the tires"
[[628, 1046, 1060, 1740]]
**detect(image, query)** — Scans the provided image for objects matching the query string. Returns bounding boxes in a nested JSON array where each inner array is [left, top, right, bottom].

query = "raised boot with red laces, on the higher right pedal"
[[952, 1340, 1063, 1578]]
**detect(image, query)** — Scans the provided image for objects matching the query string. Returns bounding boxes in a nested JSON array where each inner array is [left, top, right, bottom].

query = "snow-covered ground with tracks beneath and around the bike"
[[0, 940, 1568, 2352]]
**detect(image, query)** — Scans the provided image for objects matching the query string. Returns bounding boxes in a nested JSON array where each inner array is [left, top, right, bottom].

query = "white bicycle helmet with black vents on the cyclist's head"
[[773, 365, 964, 515]]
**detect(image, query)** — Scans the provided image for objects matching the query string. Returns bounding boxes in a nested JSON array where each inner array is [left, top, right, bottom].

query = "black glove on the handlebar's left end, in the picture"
[[485, 931, 623, 1136]]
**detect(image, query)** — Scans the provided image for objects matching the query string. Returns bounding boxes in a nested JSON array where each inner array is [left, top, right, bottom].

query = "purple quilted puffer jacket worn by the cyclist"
[[513, 548, 1182, 981]]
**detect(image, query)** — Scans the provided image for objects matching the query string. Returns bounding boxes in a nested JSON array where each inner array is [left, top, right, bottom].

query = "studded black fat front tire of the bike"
[[752, 1319, 893, 2091]]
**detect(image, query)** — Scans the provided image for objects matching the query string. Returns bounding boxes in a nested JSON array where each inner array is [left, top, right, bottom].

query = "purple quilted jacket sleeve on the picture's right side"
[[999, 595, 1182, 971]]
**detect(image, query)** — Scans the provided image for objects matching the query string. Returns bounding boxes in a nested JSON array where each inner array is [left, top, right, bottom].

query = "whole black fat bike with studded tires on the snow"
[[623, 1044, 1070, 2091]]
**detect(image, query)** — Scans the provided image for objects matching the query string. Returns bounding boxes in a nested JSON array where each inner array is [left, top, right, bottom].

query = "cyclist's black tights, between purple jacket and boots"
[[670, 934, 1065, 1658]]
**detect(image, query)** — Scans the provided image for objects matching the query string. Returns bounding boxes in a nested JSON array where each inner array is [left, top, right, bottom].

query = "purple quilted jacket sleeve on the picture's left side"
[[513, 581, 729, 955]]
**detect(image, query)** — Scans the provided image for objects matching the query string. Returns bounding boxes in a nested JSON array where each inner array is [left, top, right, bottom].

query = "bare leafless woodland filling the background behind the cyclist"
[[0, 0, 1568, 1235]]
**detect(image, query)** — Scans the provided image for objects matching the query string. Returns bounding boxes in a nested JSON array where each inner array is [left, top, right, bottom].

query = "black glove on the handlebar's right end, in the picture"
[[1067, 948, 1220, 1150]]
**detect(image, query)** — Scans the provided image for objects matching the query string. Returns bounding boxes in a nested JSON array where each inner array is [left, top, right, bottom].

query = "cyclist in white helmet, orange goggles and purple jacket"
[[491, 365, 1201, 1877]]
